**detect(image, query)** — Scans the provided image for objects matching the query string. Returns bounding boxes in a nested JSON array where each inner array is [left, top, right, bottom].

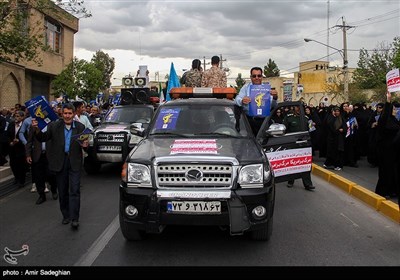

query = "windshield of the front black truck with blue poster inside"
[[150, 104, 248, 137]]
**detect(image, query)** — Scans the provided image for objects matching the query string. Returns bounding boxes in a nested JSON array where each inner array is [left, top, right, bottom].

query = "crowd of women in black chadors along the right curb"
[[271, 97, 400, 201]]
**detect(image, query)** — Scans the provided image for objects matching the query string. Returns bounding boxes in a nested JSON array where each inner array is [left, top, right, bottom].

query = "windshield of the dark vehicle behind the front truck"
[[104, 107, 154, 124]]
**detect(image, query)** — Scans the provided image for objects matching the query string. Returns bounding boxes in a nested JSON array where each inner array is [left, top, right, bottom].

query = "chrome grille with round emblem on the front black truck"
[[156, 163, 233, 188]]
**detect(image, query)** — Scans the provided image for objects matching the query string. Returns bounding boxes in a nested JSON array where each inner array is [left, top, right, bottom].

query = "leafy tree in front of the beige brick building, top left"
[[0, 0, 91, 65]]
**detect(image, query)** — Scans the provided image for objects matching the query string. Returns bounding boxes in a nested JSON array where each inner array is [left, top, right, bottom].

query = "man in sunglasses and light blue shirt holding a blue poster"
[[235, 67, 278, 136]]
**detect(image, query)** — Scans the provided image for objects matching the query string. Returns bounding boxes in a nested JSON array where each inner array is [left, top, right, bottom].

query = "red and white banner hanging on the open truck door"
[[267, 147, 312, 177]]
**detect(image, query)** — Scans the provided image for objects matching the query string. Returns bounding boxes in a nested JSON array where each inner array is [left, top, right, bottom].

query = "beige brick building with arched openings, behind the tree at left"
[[0, 0, 79, 108]]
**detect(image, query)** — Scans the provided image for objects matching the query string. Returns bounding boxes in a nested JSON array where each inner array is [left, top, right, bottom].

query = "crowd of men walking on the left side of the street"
[[0, 101, 110, 228]]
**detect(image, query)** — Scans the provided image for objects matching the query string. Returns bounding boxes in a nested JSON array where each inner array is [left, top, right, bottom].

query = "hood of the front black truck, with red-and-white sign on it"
[[128, 138, 265, 164]]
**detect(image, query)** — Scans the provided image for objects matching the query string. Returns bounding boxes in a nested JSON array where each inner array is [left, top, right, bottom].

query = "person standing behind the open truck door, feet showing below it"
[[283, 106, 315, 191]]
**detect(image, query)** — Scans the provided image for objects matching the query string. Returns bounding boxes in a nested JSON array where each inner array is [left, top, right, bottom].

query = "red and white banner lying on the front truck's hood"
[[171, 139, 218, 155]]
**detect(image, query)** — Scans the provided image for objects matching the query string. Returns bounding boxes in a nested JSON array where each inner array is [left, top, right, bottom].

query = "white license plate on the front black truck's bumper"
[[167, 201, 221, 214]]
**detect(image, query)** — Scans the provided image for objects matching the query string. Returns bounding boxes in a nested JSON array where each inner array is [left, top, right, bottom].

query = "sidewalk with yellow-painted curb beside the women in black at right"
[[312, 152, 400, 223]]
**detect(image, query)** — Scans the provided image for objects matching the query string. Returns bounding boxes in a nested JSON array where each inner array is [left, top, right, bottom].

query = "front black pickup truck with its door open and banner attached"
[[119, 88, 311, 240]]
